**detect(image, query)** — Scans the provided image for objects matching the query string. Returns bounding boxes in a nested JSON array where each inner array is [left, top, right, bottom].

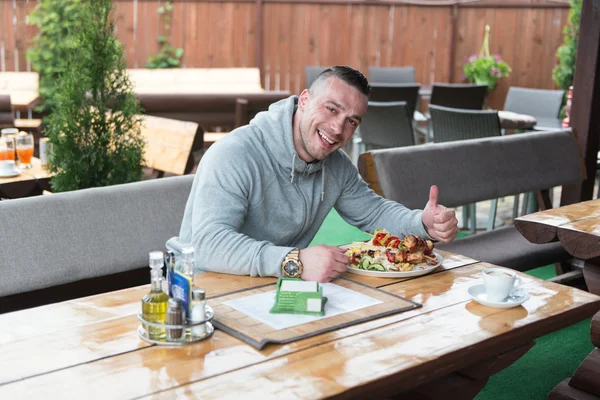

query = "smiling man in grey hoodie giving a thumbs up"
[[180, 67, 458, 282]]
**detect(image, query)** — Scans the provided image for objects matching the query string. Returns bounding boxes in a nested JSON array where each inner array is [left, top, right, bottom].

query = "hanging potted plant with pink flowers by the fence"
[[463, 25, 511, 92]]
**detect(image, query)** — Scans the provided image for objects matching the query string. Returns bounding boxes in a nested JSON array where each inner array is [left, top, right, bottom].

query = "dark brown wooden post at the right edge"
[[561, 0, 600, 205]]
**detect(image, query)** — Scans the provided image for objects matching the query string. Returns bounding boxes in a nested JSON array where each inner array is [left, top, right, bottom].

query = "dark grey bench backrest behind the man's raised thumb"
[[359, 130, 584, 208]]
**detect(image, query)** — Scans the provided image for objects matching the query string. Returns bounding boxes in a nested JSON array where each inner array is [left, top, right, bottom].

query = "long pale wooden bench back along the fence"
[[127, 68, 264, 94]]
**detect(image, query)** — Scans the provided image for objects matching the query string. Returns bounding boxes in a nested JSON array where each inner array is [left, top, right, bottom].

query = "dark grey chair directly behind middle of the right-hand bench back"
[[429, 104, 502, 233]]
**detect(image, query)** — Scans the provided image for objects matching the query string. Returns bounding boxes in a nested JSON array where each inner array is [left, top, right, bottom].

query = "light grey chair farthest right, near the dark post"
[[504, 87, 565, 130]]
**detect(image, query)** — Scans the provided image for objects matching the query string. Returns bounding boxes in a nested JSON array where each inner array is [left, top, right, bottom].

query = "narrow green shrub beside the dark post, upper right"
[[552, 0, 582, 90]]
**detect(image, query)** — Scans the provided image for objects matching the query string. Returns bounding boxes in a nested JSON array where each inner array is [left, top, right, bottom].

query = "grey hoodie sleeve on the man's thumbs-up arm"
[[335, 160, 431, 239]]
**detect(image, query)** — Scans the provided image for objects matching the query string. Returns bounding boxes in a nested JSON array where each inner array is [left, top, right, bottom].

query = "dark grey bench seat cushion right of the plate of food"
[[436, 226, 571, 271]]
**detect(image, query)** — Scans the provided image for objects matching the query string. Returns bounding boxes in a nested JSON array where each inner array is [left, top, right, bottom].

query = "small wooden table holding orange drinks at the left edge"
[[0, 157, 51, 199]]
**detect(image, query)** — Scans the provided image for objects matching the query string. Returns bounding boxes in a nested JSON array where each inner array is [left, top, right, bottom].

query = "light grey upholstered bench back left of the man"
[[0, 175, 193, 312]]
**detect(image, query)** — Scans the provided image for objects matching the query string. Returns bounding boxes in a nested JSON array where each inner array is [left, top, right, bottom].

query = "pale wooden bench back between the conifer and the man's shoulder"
[[142, 115, 203, 175]]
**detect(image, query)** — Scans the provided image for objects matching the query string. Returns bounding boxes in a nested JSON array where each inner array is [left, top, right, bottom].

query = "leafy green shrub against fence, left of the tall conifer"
[[27, 0, 81, 112]]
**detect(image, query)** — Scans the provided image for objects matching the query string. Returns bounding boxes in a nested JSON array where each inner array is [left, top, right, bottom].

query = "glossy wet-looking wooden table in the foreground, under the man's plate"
[[0, 251, 600, 399]]
